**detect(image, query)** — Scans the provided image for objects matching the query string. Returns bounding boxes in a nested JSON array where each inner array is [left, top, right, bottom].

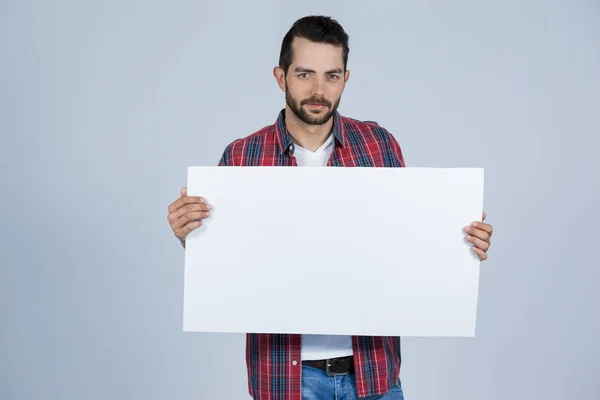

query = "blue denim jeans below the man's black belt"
[[302, 365, 404, 400]]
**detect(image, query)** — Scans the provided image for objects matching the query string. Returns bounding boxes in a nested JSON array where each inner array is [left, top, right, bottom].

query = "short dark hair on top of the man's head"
[[279, 15, 350, 74]]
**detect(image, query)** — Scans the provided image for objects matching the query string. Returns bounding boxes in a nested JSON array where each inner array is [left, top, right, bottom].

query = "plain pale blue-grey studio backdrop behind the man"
[[0, 0, 600, 400]]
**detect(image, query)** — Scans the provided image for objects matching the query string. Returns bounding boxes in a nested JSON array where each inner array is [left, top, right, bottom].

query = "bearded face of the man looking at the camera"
[[284, 38, 349, 125]]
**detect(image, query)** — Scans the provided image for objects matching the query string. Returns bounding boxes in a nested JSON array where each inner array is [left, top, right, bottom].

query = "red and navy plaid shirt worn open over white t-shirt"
[[219, 110, 405, 400]]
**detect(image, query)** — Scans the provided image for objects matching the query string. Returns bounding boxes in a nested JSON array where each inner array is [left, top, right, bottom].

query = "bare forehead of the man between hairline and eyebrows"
[[292, 37, 344, 70]]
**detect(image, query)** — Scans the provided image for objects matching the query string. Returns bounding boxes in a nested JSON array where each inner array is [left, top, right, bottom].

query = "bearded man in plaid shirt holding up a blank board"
[[168, 16, 492, 400]]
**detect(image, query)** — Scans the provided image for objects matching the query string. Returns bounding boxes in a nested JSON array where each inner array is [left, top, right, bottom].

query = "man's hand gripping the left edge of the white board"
[[167, 188, 212, 247]]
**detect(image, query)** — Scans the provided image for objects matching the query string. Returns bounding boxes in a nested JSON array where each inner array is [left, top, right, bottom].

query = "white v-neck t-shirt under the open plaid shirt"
[[294, 135, 353, 360]]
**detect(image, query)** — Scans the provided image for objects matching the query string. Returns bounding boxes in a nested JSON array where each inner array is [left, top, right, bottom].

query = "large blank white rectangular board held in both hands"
[[183, 166, 483, 337]]
